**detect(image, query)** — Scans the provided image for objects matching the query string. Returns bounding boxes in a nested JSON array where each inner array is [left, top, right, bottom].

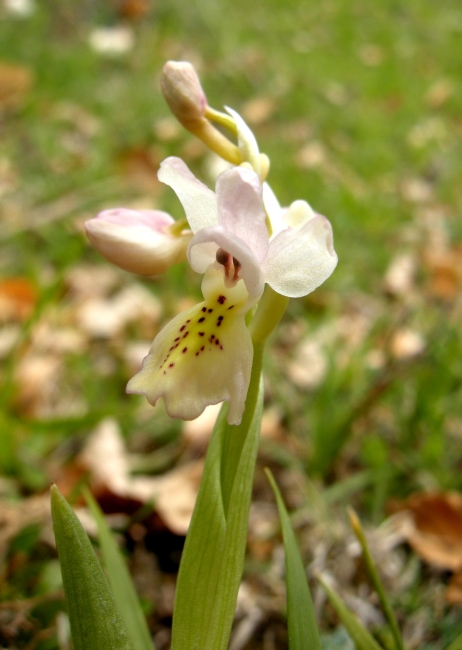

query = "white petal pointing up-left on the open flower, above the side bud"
[[157, 156, 218, 233]]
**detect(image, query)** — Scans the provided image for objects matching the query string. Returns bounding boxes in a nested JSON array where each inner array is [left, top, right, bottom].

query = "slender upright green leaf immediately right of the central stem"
[[265, 469, 321, 650]]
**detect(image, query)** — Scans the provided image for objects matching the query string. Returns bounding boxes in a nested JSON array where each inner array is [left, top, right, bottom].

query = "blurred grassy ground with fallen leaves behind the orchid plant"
[[0, 0, 462, 650]]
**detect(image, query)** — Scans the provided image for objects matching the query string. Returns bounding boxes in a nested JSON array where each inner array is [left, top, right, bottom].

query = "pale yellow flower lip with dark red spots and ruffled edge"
[[127, 268, 253, 424]]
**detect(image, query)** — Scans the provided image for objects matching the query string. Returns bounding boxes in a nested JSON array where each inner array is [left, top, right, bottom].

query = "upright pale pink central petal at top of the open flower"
[[216, 167, 269, 262]]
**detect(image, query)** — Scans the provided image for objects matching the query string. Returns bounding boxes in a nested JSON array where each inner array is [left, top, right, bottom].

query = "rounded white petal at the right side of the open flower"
[[263, 215, 337, 298]]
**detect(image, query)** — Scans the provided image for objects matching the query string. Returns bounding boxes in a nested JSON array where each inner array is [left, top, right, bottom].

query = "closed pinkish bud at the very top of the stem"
[[160, 61, 207, 132]]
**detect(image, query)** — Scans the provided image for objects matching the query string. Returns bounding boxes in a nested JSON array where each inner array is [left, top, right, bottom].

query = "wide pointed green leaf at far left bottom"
[[51, 485, 135, 650]]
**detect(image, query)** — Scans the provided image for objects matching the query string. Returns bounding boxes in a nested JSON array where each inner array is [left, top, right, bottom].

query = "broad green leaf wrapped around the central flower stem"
[[172, 344, 263, 650]]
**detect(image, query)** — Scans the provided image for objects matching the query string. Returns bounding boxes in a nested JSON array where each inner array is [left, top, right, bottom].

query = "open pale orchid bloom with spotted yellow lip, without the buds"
[[127, 157, 337, 424]]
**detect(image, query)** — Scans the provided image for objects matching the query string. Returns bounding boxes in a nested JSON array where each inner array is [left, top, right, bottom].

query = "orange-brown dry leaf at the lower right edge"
[[390, 492, 462, 572]]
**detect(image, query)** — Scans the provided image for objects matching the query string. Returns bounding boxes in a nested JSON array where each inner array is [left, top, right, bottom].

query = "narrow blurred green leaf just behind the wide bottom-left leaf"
[[83, 489, 154, 650]]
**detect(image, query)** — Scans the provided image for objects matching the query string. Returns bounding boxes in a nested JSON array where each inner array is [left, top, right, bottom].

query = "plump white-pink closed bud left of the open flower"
[[85, 208, 192, 275]]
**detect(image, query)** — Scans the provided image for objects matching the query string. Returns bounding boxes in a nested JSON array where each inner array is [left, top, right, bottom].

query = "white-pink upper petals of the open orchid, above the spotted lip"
[[158, 157, 337, 306]]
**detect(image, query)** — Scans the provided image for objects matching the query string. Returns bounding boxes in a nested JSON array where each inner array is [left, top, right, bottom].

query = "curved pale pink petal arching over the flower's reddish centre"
[[187, 226, 264, 300]]
